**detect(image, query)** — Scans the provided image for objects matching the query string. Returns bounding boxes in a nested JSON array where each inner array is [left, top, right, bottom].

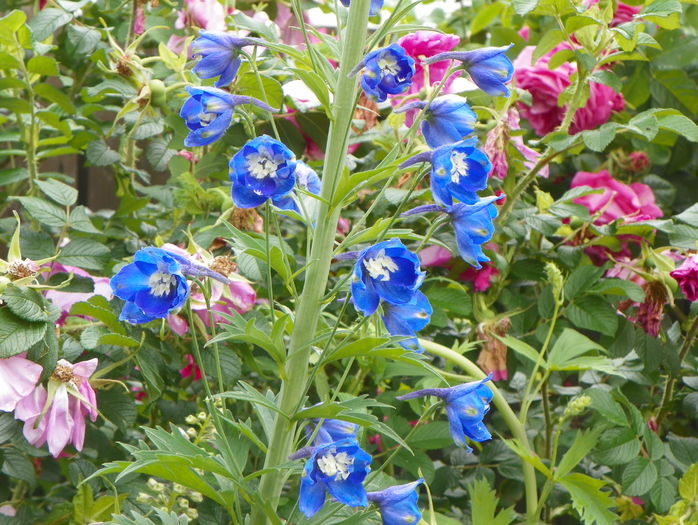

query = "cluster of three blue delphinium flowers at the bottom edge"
[[292, 419, 424, 525]]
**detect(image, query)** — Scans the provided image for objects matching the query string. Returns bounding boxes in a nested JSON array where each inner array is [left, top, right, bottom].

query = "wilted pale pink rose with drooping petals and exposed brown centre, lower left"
[[15, 359, 98, 457]]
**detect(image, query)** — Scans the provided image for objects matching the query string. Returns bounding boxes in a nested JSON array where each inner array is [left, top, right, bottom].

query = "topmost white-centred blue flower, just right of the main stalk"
[[352, 44, 415, 102]]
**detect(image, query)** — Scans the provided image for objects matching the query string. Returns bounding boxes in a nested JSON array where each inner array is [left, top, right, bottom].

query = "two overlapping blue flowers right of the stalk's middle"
[[351, 239, 432, 352]]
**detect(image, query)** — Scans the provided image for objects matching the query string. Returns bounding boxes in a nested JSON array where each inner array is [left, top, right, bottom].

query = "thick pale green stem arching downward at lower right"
[[419, 339, 538, 525]]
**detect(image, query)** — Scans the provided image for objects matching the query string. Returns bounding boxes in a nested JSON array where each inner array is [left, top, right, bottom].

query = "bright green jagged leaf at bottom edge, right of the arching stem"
[[560, 473, 618, 525]]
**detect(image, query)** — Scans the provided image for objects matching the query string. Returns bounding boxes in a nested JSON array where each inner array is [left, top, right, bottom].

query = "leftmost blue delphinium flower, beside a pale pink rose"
[[110, 246, 189, 324]]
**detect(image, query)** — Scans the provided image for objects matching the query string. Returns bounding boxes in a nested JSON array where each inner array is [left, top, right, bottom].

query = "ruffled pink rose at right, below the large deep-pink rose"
[[570, 170, 662, 224]]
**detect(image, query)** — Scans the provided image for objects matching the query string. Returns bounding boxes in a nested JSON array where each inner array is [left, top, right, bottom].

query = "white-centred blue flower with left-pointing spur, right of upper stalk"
[[400, 137, 492, 208]]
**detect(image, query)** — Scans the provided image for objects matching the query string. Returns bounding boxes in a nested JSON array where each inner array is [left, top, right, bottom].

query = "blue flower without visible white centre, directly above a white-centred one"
[[395, 95, 477, 148]]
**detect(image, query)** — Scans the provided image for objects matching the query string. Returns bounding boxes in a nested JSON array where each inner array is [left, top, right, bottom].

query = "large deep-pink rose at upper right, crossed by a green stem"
[[514, 45, 625, 136]]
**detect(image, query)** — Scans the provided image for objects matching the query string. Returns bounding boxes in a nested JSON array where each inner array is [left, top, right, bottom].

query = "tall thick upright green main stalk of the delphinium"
[[250, 0, 370, 525]]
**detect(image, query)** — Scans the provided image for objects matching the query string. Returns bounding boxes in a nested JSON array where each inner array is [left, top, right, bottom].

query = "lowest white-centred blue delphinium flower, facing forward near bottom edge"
[[298, 439, 371, 518]]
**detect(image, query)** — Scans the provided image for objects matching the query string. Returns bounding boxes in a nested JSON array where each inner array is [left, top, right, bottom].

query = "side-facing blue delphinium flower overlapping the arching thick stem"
[[397, 375, 492, 452]]
